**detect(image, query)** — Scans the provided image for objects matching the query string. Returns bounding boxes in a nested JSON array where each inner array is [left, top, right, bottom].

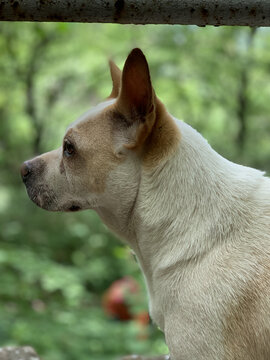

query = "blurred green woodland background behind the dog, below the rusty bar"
[[0, 23, 270, 360]]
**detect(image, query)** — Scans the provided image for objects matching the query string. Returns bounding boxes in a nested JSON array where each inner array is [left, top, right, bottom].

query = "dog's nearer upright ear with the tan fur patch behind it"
[[115, 49, 180, 167]]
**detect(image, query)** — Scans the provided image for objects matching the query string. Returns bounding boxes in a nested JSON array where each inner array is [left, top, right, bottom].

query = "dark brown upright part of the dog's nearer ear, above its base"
[[117, 49, 154, 121]]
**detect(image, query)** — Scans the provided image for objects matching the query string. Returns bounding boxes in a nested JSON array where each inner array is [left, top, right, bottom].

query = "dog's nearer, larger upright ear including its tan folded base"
[[116, 49, 155, 148]]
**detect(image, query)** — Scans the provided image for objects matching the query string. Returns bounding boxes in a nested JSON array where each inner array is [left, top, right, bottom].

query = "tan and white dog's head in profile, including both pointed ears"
[[21, 49, 180, 215]]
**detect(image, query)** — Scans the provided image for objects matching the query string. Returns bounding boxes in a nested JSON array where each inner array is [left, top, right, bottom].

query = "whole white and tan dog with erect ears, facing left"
[[21, 49, 270, 360]]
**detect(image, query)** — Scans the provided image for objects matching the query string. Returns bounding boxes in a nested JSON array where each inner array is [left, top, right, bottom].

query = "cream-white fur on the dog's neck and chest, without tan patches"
[[97, 116, 270, 360]]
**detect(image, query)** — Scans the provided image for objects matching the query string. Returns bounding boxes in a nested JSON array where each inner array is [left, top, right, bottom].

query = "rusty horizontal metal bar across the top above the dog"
[[0, 0, 270, 27]]
